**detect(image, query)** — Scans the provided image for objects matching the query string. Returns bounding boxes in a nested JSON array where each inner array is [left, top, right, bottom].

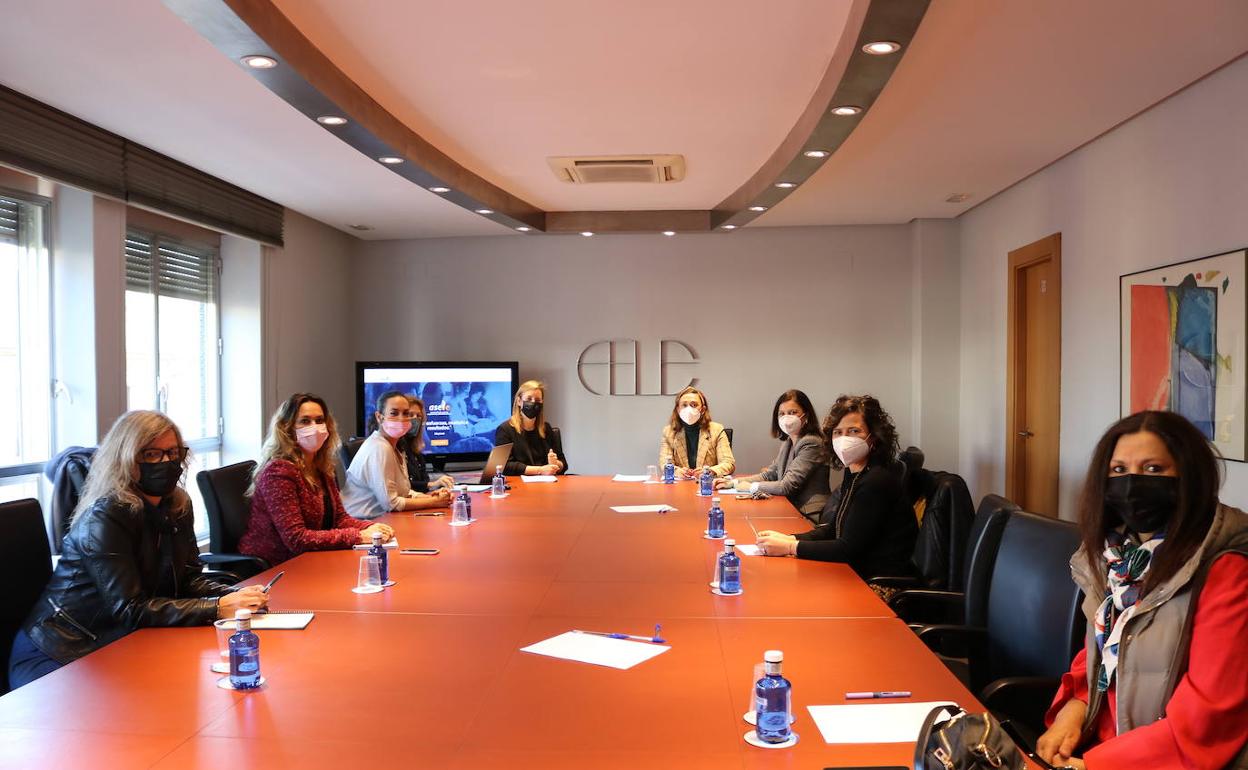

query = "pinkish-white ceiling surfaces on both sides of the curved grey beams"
[[0, 0, 1248, 238]]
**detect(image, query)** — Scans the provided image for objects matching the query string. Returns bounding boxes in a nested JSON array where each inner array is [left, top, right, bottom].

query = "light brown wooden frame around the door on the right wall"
[[1006, 232, 1062, 518]]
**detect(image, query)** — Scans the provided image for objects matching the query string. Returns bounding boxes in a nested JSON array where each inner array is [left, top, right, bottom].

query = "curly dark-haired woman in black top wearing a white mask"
[[758, 396, 919, 578]]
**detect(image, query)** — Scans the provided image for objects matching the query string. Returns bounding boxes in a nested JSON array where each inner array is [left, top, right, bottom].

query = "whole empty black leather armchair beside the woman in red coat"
[[919, 510, 1085, 740]]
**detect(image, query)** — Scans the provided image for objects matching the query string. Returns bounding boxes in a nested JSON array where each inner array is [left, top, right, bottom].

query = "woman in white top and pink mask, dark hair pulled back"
[[342, 391, 451, 519]]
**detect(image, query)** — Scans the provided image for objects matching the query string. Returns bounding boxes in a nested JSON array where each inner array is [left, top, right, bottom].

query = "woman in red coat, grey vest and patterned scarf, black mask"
[[1036, 412, 1248, 770]]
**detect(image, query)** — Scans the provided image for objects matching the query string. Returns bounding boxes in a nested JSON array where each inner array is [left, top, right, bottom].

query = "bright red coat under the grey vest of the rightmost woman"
[[1046, 553, 1248, 770]]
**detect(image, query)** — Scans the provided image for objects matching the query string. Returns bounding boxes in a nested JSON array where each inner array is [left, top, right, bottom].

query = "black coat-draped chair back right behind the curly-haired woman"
[[911, 469, 973, 590]]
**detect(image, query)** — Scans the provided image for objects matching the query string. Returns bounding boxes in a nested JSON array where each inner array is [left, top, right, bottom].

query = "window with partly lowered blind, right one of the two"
[[126, 228, 223, 538]]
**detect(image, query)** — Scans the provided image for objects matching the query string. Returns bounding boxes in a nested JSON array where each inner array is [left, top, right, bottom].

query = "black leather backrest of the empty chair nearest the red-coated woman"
[[971, 510, 1083, 691]]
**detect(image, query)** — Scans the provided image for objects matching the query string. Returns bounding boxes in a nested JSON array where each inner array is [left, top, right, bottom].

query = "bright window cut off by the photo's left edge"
[[0, 192, 52, 500]]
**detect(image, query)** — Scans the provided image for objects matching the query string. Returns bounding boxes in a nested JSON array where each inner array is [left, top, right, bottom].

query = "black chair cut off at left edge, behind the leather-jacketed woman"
[[0, 499, 52, 695]]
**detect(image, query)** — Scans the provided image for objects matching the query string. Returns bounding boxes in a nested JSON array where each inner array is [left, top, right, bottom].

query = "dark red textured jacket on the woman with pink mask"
[[238, 459, 369, 564]]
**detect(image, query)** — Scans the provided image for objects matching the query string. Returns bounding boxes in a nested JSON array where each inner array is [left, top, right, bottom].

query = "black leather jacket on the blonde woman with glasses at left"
[[22, 493, 232, 663]]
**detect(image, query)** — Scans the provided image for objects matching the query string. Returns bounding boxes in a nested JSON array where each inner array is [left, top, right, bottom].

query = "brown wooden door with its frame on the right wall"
[[1006, 233, 1062, 518]]
